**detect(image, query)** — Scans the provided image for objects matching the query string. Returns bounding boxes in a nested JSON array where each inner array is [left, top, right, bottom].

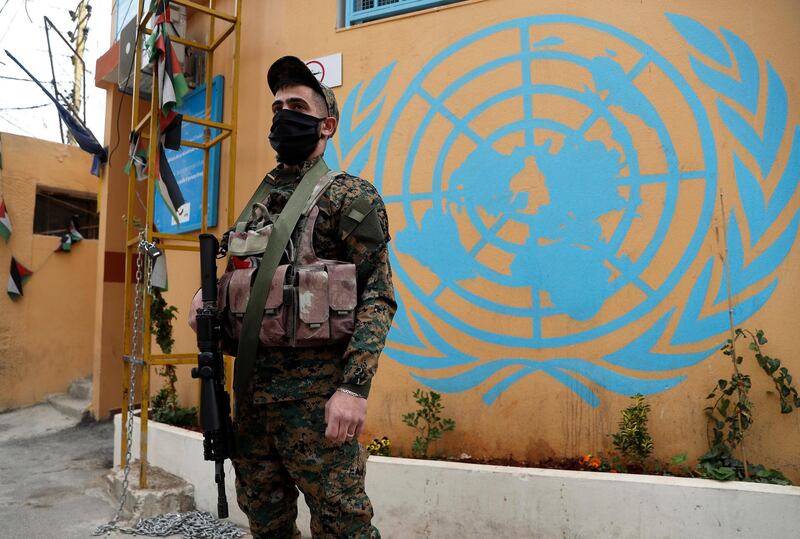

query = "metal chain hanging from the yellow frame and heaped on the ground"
[[92, 235, 245, 539]]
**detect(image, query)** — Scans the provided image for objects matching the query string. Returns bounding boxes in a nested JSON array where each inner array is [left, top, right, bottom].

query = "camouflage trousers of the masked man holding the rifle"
[[233, 397, 380, 539]]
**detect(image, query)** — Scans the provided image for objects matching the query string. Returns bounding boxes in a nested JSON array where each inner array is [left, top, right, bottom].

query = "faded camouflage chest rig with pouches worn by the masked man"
[[189, 159, 358, 392]]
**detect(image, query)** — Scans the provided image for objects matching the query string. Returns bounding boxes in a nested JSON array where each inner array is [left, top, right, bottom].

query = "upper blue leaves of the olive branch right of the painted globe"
[[667, 14, 800, 350]]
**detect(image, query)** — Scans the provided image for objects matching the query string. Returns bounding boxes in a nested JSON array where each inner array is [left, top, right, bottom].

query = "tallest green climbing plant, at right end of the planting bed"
[[697, 328, 800, 484]]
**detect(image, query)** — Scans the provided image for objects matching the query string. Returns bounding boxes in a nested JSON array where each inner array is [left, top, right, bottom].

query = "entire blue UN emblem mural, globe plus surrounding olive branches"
[[326, 15, 800, 406]]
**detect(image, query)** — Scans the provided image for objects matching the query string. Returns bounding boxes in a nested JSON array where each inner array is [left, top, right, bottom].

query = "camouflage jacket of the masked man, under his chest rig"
[[223, 161, 397, 403]]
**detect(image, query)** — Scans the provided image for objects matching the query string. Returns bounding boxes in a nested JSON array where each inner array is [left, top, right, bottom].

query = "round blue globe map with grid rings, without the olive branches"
[[376, 15, 717, 348]]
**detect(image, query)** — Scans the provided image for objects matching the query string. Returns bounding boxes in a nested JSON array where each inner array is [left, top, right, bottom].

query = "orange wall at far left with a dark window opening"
[[0, 133, 97, 410]]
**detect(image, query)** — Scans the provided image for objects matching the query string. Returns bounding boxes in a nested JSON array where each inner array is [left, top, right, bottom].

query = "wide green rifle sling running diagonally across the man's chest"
[[233, 159, 329, 398]]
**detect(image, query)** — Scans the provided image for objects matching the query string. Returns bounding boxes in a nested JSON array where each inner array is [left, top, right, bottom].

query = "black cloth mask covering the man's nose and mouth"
[[269, 109, 323, 165]]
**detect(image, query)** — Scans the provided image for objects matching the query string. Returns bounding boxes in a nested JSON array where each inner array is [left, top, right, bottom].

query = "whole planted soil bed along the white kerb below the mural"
[[367, 328, 800, 485]]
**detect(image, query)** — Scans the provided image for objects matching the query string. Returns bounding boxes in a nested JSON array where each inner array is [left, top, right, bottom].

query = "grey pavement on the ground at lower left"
[[0, 404, 250, 539]]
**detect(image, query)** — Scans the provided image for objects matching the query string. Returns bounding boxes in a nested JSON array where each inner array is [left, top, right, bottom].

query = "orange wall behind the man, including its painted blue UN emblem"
[[95, 0, 800, 480]]
